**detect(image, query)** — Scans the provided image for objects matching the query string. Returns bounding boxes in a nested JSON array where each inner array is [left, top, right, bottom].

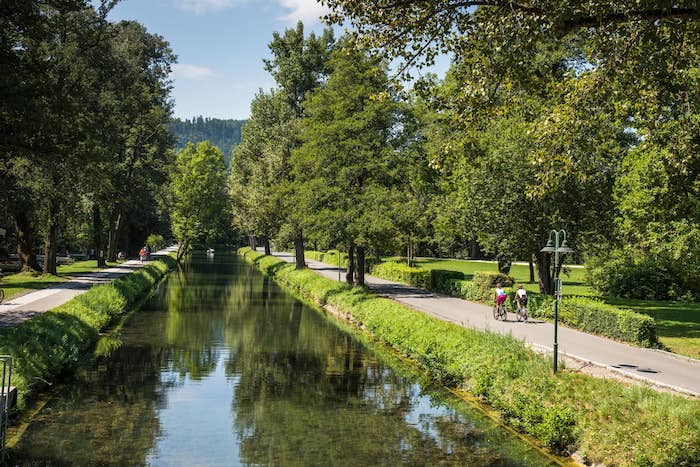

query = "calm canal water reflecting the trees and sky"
[[11, 252, 551, 466]]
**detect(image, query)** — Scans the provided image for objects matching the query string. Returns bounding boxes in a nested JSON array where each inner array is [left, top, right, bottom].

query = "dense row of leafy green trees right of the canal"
[[231, 4, 700, 300]]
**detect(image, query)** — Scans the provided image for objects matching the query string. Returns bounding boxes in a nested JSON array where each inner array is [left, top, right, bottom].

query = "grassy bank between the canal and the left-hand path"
[[0, 256, 175, 412]]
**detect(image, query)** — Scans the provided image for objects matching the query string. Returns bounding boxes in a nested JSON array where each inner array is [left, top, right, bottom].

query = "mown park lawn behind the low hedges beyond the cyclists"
[[404, 258, 700, 359]]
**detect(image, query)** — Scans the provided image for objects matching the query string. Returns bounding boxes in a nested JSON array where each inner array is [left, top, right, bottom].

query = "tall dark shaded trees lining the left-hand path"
[[0, 0, 175, 273]]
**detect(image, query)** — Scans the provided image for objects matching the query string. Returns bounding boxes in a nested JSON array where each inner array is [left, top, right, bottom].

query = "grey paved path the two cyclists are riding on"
[[273, 252, 700, 397]]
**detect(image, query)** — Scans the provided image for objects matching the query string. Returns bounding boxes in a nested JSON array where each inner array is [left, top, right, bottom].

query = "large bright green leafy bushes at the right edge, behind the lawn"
[[588, 143, 700, 299]]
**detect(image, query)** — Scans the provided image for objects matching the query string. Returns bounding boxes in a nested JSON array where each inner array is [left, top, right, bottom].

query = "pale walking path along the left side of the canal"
[[0, 245, 177, 328]]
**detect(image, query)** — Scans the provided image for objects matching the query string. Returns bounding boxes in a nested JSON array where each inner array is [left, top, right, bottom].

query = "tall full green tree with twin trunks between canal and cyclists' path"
[[292, 42, 403, 285]]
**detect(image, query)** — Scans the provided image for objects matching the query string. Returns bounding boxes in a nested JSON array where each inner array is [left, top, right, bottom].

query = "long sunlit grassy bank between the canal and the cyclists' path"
[[240, 248, 700, 465]]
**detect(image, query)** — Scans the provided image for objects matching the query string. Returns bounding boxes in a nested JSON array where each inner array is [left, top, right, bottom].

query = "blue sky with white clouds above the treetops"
[[110, 0, 447, 119]]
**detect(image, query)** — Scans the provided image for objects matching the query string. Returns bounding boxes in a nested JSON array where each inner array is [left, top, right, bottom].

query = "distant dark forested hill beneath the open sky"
[[170, 116, 246, 165]]
